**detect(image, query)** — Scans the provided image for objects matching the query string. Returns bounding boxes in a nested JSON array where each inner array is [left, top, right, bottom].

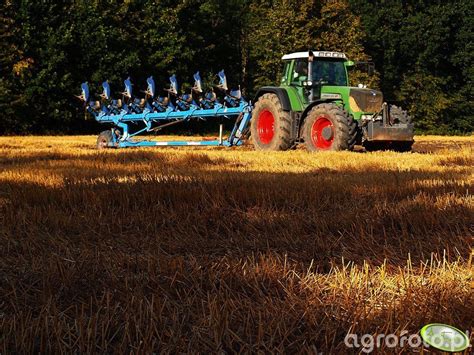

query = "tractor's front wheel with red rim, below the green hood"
[[302, 103, 357, 152]]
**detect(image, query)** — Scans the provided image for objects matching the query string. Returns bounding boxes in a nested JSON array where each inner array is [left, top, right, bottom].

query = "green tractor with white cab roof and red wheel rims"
[[250, 51, 414, 151]]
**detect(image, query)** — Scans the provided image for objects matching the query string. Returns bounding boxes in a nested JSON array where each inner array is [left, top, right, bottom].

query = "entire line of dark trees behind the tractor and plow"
[[0, 0, 474, 134]]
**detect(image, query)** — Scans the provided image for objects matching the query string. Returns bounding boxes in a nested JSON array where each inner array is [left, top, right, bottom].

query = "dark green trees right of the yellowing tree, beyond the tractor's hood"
[[350, 0, 474, 134]]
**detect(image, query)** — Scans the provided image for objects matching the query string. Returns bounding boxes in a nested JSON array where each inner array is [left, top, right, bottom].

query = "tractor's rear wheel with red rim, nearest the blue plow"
[[250, 93, 291, 150]]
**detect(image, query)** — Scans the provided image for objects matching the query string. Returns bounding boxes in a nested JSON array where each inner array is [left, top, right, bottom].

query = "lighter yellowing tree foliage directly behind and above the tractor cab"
[[248, 0, 377, 88]]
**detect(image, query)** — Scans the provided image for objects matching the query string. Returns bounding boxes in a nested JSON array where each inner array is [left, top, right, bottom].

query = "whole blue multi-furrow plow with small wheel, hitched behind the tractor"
[[77, 70, 252, 148]]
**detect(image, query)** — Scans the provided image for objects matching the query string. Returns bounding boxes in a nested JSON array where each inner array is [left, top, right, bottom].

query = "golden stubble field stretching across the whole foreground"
[[0, 136, 474, 354]]
